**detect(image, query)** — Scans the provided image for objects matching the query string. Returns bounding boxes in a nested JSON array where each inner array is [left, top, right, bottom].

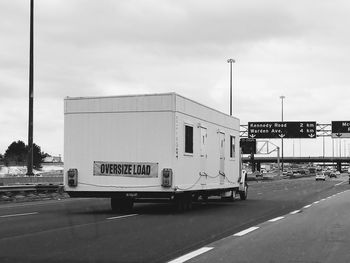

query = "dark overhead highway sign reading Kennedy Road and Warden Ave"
[[248, 121, 316, 139]]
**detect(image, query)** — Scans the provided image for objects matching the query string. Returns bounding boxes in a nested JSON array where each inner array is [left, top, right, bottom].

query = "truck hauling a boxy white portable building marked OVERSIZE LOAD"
[[64, 93, 248, 211]]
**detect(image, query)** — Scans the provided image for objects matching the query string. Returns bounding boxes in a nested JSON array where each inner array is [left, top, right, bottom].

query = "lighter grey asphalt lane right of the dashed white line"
[[188, 185, 350, 263]]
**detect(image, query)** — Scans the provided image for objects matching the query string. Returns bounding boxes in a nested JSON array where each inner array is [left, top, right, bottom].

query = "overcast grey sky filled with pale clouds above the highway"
[[0, 0, 350, 159]]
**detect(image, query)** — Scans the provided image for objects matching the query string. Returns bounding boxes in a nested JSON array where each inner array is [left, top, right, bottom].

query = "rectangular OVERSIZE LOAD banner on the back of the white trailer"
[[94, 161, 158, 178]]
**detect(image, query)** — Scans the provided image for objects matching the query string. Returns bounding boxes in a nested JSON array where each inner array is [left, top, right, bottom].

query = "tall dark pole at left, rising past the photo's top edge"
[[27, 0, 34, 175]]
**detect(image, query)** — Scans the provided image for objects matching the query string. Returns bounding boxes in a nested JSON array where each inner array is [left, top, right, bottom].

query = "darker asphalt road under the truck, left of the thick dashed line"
[[0, 178, 350, 262]]
